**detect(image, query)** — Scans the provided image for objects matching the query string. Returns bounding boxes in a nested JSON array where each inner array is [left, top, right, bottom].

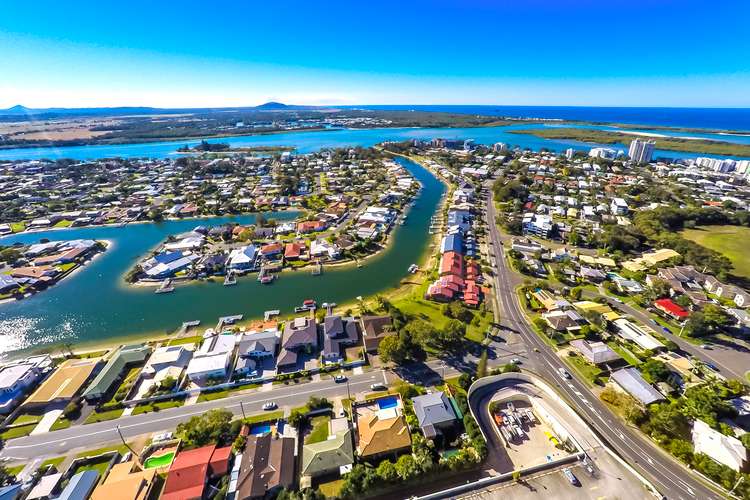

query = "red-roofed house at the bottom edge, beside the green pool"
[[160, 444, 232, 500]]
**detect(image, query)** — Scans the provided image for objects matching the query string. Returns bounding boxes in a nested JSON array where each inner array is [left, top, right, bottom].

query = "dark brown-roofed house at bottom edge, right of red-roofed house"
[[236, 433, 295, 500]]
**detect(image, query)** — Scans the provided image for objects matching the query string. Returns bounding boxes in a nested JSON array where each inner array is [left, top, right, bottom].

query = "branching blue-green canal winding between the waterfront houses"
[[0, 158, 445, 356]]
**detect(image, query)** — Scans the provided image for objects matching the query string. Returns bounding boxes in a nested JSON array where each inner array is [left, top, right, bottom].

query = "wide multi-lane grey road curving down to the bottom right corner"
[[487, 187, 723, 500]]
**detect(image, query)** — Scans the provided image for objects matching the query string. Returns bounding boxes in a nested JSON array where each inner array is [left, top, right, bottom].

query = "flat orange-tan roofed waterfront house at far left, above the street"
[[23, 358, 101, 407]]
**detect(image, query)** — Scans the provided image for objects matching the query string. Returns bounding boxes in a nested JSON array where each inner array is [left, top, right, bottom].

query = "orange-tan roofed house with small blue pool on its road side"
[[355, 396, 411, 459]]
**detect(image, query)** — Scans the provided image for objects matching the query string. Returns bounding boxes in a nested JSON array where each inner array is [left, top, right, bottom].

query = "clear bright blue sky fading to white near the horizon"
[[0, 0, 750, 108]]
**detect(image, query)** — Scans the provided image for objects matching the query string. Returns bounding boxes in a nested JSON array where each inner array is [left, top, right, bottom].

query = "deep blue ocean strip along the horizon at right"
[[350, 105, 750, 131]]
